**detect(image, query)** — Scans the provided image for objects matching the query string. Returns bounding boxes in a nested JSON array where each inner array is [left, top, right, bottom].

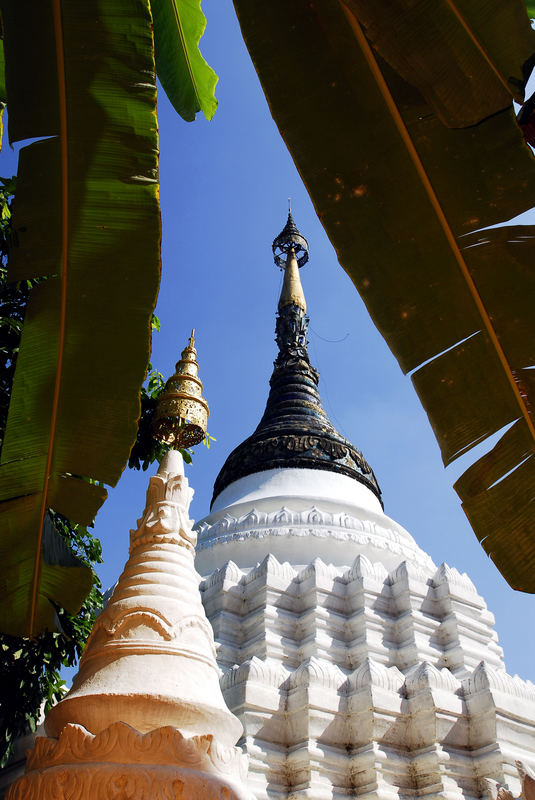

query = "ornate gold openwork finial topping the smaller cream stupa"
[[153, 328, 210, 449]]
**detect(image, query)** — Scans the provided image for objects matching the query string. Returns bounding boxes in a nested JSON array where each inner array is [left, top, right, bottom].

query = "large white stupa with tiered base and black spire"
[[196, 214, 535, 800]]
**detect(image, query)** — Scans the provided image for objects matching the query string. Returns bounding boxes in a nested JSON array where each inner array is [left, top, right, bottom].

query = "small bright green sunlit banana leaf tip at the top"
[[151, 0, 218, 122]]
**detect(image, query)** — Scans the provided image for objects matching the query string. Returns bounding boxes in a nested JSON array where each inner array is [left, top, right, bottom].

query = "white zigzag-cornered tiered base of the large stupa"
[[201, 545, 535, 800]]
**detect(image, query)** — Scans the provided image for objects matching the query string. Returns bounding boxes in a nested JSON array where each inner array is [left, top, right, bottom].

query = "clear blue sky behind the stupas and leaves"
[[0, 0, 535, 679]]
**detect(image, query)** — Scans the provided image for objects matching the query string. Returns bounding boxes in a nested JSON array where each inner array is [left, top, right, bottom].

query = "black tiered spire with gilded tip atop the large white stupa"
[[212, 213, 381, 503]]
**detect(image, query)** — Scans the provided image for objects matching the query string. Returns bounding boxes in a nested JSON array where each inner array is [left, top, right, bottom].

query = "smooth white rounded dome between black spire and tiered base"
[[196, 468, 436, 575]]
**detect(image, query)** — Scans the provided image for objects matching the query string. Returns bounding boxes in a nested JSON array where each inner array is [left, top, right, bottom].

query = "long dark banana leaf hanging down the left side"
[[0, 0, 160, 636]]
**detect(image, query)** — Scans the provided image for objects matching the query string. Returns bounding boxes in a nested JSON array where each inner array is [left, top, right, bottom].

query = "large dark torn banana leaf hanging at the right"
[[234, 0, 535, 592]]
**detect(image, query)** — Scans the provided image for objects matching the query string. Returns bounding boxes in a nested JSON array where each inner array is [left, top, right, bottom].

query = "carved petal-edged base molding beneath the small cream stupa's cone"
[[6, 722, 252, 800]]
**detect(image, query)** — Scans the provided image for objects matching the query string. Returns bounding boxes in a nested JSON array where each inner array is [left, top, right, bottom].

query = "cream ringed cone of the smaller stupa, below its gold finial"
[[45, 450, 242, 745]]
